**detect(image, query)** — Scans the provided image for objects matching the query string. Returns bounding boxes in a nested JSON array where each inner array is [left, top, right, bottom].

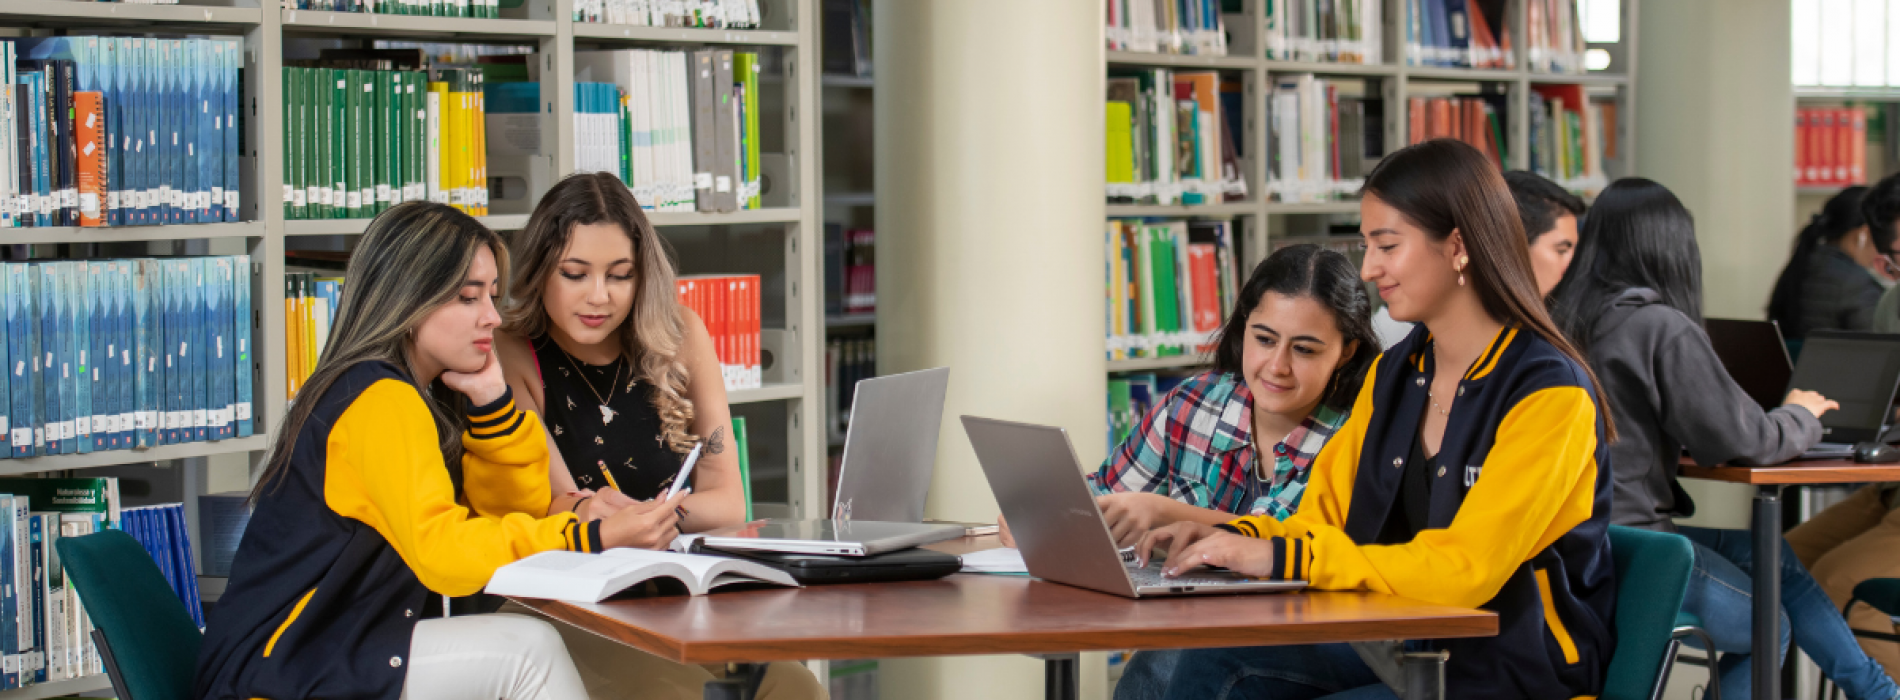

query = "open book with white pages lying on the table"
[[486, 550, 798, 603]]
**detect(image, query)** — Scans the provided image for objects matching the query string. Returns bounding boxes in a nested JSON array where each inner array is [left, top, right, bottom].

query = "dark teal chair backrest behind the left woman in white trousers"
[[55, 531, 203, 700]]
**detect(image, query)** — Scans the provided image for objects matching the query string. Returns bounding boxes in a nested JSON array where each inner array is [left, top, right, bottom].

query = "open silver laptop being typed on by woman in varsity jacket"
[[963, 417, 1307, 597]]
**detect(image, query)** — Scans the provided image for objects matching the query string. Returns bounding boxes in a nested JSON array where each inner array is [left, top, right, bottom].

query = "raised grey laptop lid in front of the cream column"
[[832, 367, 950, 523]]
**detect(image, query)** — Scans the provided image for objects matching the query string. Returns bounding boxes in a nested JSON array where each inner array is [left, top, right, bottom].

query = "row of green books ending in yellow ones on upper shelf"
[[283, 65, 488, 219]]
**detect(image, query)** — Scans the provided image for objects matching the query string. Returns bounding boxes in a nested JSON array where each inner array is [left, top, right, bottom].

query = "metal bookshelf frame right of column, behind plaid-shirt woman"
[[1104, 0, 1641, 373]]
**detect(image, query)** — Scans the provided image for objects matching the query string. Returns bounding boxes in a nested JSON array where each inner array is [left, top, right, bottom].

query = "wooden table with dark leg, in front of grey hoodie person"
[[1682, 458, 1900, 700]]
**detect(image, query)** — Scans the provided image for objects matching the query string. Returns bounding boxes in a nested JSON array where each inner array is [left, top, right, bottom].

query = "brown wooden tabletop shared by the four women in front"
[[517, 538, 1497, 696]]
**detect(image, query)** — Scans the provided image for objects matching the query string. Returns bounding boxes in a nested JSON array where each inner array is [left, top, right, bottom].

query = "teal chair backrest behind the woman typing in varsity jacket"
[[1602, 525, 1695, 700]]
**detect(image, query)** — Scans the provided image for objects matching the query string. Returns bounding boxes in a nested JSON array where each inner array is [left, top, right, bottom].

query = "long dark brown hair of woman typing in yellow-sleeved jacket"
[[1360, 139, 1617, 441]]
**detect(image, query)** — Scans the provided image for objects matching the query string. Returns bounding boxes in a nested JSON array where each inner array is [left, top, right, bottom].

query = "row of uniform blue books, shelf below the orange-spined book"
[[0, 255, 255, 457]]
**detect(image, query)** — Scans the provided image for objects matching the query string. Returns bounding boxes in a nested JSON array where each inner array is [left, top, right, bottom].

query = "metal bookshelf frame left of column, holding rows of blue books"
[[0, 0, 825, 688]]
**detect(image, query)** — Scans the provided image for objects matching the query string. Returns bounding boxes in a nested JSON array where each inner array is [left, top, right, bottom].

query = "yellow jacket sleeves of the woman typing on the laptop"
[[1227, 377, 1598, 607]]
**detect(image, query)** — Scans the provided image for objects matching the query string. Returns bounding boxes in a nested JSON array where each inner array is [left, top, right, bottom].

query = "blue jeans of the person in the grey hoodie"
[[1680, 527, 1900, 700]]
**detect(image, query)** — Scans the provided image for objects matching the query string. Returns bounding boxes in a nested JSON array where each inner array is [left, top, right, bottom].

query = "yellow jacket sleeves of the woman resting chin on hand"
[[323, 379, 600, 595]]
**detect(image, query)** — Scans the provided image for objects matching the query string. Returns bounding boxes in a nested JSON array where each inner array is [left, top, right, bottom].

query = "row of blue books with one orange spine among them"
[[0, 36, 243, 228]]
